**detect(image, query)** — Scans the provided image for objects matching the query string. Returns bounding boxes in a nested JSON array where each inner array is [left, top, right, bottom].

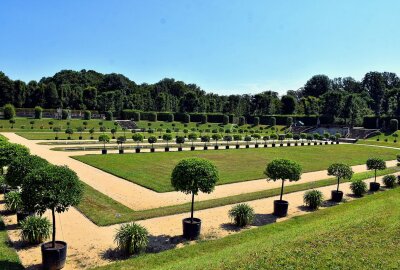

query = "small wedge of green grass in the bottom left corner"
[[0, 217, 24, 270]]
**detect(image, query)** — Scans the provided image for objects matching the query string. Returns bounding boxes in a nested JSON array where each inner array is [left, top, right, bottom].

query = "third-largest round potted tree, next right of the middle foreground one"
[[264, 158, 302, 217]]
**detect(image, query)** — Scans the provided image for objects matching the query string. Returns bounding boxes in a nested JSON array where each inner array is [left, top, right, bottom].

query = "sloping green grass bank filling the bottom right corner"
[[94, 188, 400, 270]]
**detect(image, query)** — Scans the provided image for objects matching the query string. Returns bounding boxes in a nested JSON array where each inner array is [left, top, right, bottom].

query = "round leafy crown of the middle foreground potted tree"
[[171, 158, 219, 195]]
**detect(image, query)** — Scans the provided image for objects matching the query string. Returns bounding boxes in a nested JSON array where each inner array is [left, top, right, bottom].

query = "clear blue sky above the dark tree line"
[[0, 0, 400, 94]]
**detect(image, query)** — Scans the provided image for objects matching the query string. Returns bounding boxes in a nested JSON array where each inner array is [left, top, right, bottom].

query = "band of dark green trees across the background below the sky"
[[0, 70, 400, 124]]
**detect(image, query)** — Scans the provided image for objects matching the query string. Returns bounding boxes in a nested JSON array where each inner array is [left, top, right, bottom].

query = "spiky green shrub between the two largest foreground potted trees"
[[114, 222, 149, 255]]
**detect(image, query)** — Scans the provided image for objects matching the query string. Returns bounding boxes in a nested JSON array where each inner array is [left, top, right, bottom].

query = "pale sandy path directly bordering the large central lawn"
[[2, 133, 397, 210]]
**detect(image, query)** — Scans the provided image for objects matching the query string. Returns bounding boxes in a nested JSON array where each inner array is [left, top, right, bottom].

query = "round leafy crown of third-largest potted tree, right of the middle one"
[[264, 158, 302, 182]]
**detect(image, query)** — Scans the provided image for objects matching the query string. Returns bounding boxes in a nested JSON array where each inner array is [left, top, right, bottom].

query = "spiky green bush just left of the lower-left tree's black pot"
[[21, 216, 51, 244]]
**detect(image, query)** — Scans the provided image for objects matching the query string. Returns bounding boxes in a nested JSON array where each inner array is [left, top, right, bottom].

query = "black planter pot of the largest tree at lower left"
[[40, 241, 67, 270]]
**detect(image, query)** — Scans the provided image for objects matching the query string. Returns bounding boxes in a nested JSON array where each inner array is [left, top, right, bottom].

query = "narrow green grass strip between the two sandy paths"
[[77, 168, 398, 226]]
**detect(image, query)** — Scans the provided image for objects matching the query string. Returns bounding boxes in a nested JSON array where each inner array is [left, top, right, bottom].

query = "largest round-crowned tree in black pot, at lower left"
[[21, 165, 83, 269]]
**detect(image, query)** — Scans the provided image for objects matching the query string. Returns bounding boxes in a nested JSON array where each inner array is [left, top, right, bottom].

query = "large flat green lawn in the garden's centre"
[[74, 145, 399, 192]]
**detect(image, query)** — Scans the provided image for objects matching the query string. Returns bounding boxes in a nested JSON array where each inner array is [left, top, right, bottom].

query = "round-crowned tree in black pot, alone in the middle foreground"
[[171, 158, 219, 240]]
